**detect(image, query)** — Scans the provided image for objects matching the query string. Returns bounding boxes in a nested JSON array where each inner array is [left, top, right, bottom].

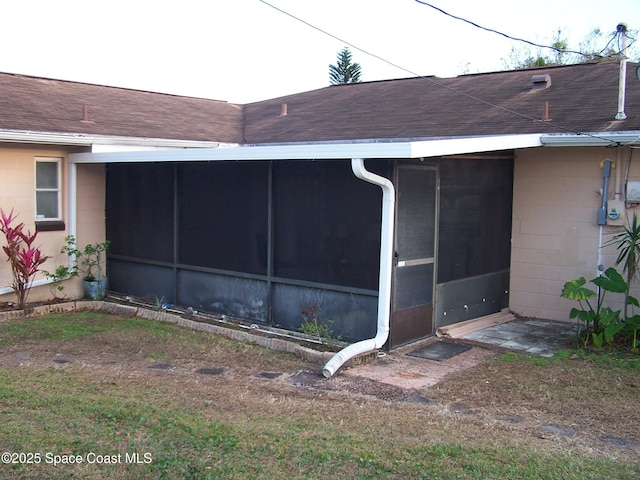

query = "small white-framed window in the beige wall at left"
[[36, 157, 62, 230]]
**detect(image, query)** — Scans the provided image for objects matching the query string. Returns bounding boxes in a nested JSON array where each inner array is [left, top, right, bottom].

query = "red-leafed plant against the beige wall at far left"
[[0, 209, 49, 308]]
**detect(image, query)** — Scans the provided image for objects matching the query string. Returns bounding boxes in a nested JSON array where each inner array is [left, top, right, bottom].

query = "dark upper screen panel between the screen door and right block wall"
[[438, 158, 513, 283]]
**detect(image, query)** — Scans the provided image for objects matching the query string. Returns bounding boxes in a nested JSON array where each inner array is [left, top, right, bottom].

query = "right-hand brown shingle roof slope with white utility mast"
[[245, 63, 640, 144]]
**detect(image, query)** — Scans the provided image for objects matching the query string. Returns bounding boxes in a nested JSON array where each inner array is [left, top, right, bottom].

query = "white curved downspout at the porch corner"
[[322, 158, 395, 378]]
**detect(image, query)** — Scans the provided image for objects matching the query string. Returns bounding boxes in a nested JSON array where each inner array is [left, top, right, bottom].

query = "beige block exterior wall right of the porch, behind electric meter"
[[509, 147, 640, 320]]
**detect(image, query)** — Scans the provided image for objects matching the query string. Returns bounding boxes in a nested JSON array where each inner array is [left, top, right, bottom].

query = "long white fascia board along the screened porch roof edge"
[[69, 135, 542, 163]]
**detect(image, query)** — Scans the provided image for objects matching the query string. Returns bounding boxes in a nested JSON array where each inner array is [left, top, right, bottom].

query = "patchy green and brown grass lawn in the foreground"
[[0, 313, 640, 480]]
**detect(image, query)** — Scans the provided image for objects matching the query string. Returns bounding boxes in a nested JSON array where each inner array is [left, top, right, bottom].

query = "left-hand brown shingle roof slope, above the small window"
[[0, 73, 242, 143]]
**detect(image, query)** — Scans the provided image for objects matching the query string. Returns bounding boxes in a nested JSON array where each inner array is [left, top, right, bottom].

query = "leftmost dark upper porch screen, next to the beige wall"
[[106, 163, 174, 262]]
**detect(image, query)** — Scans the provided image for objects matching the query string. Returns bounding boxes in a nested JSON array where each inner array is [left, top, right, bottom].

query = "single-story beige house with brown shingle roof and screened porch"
[[0, 62, 640, 374]]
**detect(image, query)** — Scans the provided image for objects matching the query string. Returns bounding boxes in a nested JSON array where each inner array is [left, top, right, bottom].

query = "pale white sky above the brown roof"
[[0, 0, 640, 104]]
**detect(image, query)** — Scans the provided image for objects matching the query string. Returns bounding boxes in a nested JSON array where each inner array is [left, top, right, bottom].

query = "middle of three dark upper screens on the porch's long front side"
[[178, 162, 269, 274]]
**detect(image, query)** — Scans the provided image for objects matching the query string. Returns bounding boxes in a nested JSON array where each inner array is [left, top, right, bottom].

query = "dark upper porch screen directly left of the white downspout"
[[273, 160, 382, 289]]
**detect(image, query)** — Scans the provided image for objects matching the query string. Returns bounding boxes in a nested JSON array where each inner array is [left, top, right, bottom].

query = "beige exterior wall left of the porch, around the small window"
[[0, 145, 105, 302]]
